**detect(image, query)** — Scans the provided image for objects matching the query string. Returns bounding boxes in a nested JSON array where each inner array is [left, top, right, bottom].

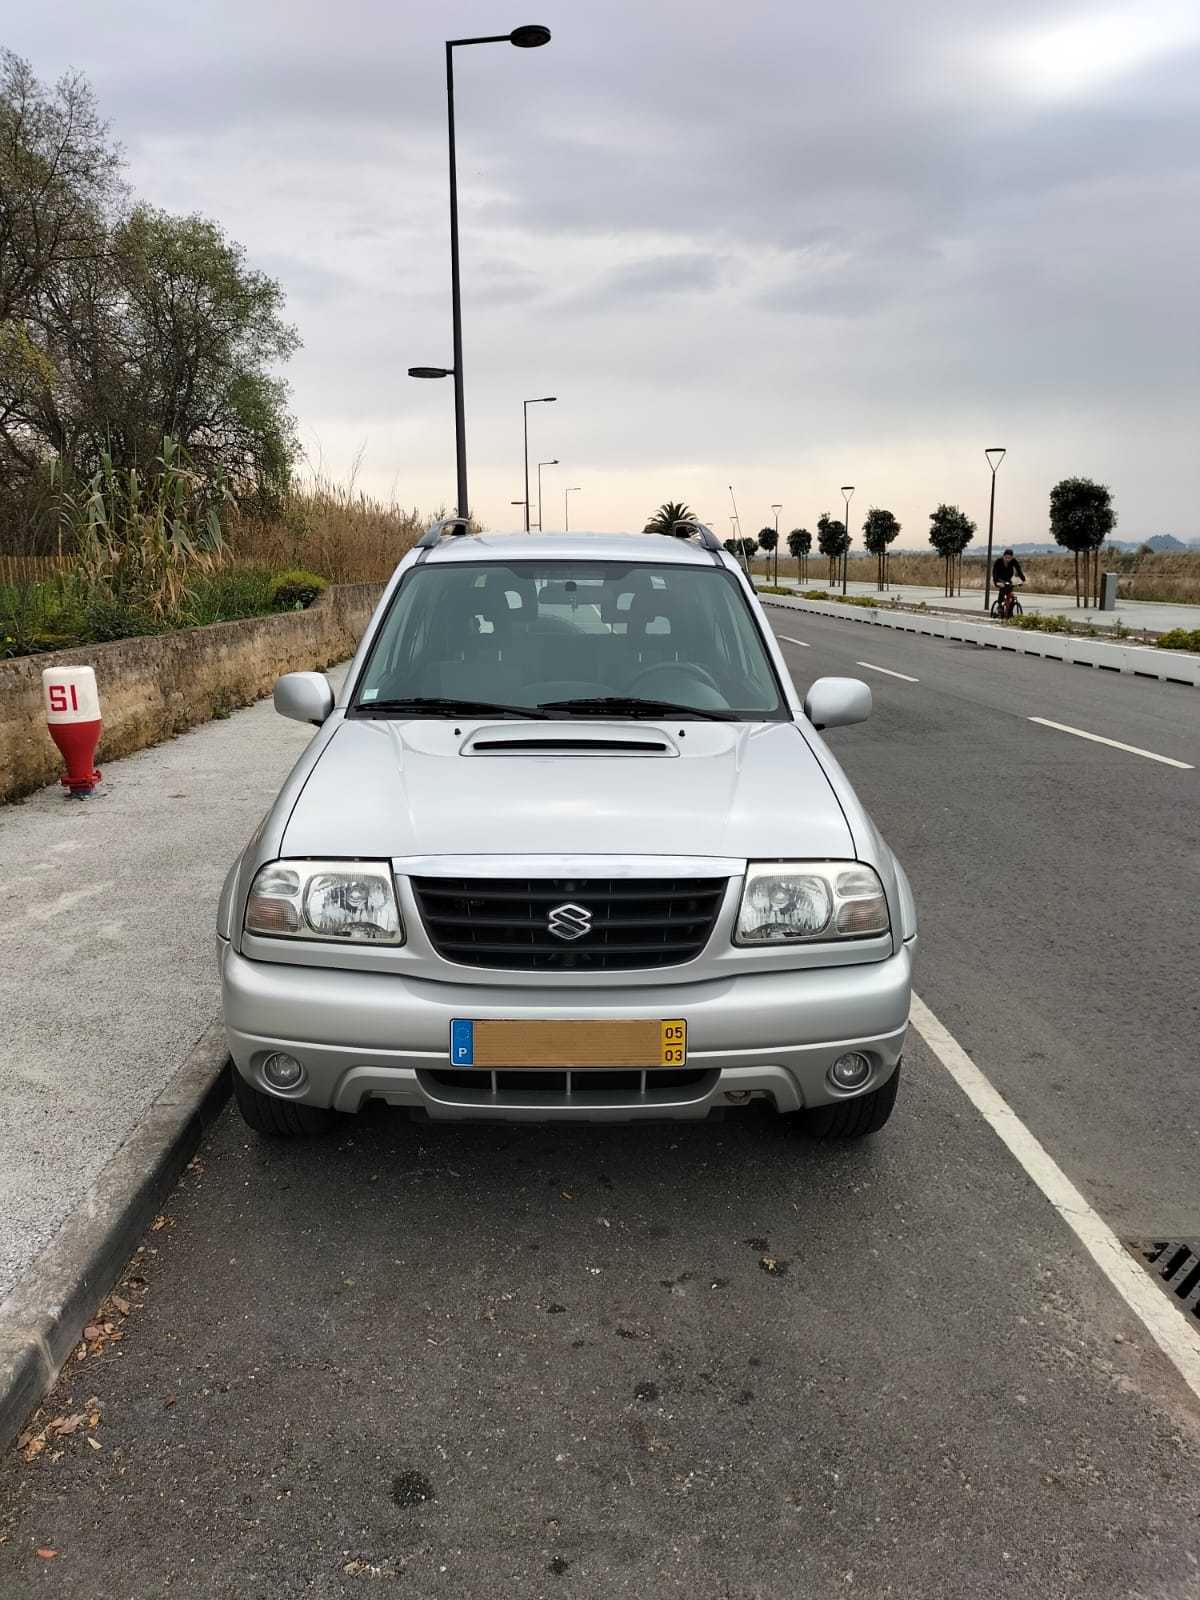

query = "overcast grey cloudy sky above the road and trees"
[[9, 0, 1200, 546]]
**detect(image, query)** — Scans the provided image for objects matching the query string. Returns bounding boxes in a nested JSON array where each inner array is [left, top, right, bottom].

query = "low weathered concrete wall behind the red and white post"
[[0, 584, 382, 800]]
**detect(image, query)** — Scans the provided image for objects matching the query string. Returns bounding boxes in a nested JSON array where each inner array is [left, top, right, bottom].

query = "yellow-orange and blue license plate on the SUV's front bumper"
[[450, 1018, 688, 1067]]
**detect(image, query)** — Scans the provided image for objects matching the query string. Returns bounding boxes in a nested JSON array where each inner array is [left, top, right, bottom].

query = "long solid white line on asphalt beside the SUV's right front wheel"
[[912, 995, 1200, 1400]]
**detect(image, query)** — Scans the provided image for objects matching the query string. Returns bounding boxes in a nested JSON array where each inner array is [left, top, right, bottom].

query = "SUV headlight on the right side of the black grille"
[[734, 861, 891, 944]]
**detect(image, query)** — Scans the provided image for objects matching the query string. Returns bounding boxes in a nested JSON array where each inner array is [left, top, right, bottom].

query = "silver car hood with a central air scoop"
[[280, 718, 854, 859]]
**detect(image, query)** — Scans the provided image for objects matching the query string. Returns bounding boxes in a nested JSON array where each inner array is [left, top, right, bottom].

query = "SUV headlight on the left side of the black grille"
[[246, 861, 405, 944]]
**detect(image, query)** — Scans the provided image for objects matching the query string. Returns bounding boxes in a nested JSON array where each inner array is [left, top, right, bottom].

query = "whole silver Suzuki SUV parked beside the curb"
[[218, 523, 917, 1138]]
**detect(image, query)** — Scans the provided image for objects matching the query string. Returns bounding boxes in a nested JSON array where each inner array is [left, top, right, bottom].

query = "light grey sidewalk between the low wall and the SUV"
[[0, 668, 345, 1301]]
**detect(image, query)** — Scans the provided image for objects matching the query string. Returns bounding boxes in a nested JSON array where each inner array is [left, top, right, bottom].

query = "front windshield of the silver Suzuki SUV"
[[352, 560, 790, 722]]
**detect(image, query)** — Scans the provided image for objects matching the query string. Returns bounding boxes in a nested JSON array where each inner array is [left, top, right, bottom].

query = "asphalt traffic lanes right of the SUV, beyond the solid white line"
[[768, 608, 1200, 1238]]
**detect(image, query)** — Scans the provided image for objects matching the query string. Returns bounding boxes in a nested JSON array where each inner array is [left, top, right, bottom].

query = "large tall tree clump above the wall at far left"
[[0, 58, 298, 528]]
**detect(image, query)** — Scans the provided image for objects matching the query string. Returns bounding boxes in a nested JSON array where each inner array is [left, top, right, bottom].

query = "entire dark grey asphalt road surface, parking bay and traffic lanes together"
[[0, 613, 1200, 1600]]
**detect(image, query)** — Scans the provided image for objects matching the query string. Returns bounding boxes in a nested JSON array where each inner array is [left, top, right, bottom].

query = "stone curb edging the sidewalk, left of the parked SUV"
[[0, 1021, 229, 1451]]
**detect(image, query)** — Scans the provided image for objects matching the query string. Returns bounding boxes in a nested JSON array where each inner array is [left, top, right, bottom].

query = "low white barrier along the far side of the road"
[[760, 594, 1200, 688]]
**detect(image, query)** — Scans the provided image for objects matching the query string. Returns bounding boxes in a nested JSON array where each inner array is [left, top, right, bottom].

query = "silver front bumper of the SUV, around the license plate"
[[219, 941, 912, 1122]]
